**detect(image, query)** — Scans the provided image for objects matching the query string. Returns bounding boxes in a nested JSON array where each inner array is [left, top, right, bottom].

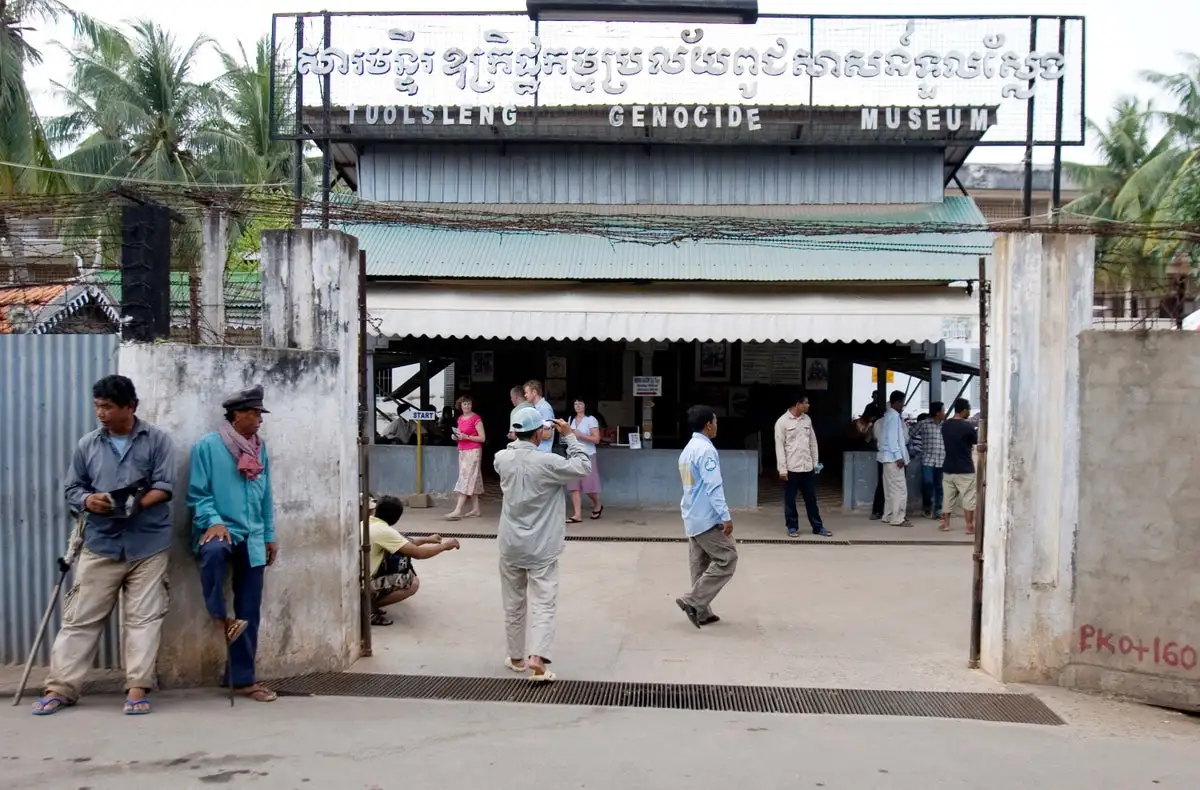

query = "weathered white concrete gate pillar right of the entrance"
[[980, 234, 1094, 682]]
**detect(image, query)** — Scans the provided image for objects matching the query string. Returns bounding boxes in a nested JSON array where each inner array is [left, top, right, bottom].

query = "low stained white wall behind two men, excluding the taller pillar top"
[[120, 343, 359, 687]]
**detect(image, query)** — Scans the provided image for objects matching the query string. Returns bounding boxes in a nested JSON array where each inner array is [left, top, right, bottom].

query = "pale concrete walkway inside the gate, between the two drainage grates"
[[355, 537, 1001, 692]]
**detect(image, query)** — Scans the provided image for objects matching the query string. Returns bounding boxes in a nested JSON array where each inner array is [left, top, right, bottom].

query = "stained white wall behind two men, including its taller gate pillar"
[[120, 225, 361, 687]]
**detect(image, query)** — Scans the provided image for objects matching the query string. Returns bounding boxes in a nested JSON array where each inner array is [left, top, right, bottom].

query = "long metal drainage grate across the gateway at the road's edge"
[[272, 672, 1064, 725]]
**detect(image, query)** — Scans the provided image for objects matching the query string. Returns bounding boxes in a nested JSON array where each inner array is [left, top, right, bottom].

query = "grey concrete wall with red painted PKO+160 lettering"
[[1061, 331, 1200, 710]]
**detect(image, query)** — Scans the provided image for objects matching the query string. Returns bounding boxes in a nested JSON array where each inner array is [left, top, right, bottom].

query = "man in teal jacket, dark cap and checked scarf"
[[187, 387, 278, 702]]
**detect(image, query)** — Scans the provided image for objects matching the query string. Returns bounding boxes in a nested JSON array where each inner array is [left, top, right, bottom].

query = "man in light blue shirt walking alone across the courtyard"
[[676, 406, 738, 628]]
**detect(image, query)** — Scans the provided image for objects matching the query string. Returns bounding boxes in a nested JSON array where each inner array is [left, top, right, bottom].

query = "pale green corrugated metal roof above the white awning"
[[342, 197, 991, 282]]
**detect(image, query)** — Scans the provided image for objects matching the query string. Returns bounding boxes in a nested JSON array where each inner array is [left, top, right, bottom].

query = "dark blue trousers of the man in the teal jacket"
[[200, 540, 265, 687]]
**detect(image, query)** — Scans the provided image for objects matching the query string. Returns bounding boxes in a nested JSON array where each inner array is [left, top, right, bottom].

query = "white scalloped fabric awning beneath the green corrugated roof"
[[367, 283, 979, 342]]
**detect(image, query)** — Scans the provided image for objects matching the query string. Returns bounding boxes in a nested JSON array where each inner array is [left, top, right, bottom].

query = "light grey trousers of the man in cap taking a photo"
[[500, 559, 558, 660]]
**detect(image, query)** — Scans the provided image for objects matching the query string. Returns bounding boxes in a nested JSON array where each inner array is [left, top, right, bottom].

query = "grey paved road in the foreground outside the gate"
[[0, 693, 1200, 790]]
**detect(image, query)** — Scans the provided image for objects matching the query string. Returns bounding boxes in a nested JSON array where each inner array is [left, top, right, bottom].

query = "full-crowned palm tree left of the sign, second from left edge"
[[47, 20, 251, 190]]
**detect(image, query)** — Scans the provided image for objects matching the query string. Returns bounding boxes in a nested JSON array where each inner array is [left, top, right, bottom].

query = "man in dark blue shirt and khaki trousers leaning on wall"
[[34, 376, 175, 716]]
